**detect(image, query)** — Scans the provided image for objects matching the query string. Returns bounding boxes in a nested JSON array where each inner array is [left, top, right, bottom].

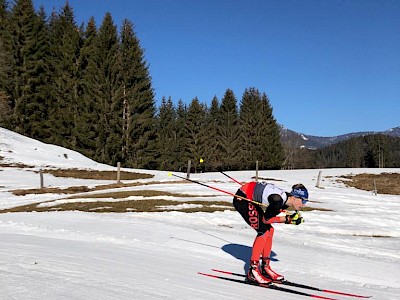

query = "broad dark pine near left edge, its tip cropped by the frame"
[[10, 0, 50, 139]]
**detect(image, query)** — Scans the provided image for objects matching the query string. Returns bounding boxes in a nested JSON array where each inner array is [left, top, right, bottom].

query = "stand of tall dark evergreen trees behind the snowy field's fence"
[[0, 0, 284, 170]]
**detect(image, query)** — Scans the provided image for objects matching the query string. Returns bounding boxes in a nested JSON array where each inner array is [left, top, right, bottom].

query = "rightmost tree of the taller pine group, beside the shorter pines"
[[120, 20, 157, 168]]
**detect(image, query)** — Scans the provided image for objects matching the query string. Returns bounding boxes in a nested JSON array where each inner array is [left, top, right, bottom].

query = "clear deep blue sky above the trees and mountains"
[[33, 0, 400, 136]]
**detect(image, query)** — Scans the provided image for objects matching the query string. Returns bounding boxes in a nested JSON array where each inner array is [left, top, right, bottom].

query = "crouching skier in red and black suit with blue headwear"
[[233, 182, 308, 283]]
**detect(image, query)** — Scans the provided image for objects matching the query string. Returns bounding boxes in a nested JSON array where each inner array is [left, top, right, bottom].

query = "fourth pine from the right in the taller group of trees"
[[49, 2, 81, 149]]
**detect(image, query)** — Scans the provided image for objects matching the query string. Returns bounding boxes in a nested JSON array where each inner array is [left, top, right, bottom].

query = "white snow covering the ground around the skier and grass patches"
[[0, 128, 400, 300]]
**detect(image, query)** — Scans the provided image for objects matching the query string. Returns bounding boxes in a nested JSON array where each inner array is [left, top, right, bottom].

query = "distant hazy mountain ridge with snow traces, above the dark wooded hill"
[[280, 126, 400, 149]]
